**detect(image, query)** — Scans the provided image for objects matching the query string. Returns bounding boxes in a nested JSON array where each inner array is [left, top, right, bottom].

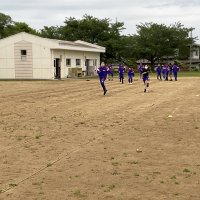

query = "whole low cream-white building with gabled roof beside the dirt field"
[[0, 32, 105, 79]]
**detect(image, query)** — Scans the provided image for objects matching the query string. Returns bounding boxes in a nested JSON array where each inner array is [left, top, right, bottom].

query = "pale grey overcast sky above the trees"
[[0, 0, 200, 40]]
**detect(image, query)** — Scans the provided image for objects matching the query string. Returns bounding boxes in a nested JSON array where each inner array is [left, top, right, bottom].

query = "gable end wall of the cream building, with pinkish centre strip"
[[0, 35, 54, 79]]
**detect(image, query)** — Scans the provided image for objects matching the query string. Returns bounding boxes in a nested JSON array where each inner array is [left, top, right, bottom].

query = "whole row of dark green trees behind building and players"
[[0, 13, 197, 66]]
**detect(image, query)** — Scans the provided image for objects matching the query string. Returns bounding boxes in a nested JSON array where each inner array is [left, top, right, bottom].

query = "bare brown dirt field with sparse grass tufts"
[[0, 78, 200, 200]]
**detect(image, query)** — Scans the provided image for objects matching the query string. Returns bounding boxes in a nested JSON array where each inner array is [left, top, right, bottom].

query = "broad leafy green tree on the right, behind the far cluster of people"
[[136, 23, 195, 66]]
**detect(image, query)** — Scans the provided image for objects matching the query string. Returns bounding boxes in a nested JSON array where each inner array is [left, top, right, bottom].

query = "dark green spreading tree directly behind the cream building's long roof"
[[41, 15, 126, 65]]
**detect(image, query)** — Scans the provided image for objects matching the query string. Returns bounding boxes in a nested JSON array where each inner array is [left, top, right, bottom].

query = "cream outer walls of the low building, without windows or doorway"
[[0, 33, 100, 79]]
